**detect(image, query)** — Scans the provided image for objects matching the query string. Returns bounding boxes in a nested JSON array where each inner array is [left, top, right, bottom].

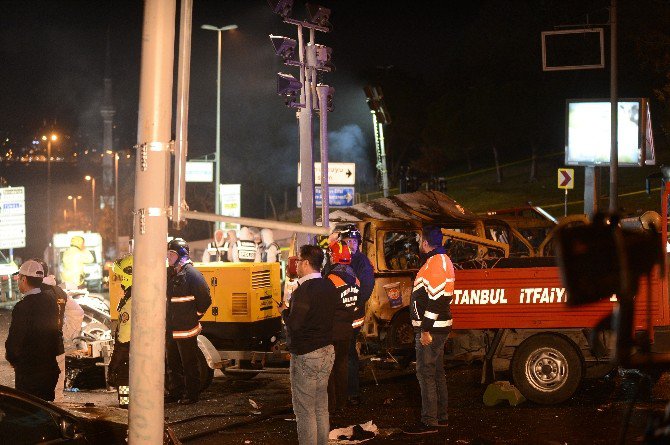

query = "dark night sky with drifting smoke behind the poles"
[[0, 0, 668, 256]]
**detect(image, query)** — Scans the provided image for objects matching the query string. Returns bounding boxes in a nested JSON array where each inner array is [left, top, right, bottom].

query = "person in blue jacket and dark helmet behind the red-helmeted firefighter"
[[339, 224, 375, 405]]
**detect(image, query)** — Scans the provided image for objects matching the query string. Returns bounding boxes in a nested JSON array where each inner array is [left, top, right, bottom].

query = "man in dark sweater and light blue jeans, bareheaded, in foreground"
[[280, 245, 340, 445]]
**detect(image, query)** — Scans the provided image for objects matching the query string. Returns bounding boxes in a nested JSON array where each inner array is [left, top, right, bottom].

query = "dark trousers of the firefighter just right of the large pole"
[[166, 336, 200, 400]]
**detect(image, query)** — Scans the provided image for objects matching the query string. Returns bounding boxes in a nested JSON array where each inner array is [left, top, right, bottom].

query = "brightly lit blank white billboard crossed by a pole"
[[565, 98, 655, 167]]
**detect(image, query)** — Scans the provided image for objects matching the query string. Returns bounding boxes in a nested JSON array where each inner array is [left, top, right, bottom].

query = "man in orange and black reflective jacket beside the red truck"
[[403, 226, 455, 434]]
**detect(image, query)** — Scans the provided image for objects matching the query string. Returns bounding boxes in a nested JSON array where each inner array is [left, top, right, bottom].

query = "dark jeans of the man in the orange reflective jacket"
[[415, 333, 449, 425]]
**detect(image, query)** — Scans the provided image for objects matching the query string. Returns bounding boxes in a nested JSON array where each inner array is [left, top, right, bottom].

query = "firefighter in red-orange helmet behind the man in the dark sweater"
[[324, 241, 360, 413]]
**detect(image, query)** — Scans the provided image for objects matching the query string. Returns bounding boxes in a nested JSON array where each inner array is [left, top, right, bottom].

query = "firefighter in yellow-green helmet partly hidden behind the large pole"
[[107, 254, 133, 408]]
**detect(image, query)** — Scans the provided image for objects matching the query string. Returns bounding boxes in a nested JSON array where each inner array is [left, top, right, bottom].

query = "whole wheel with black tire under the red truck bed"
[[512, 334, 584, 405]]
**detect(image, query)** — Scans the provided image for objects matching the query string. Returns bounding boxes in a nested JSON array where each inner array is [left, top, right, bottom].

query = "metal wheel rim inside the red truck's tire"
[[525, 348, 568, 392]]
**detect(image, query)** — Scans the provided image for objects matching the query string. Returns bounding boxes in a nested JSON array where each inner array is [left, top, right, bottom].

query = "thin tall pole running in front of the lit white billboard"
[[609, 0, 619, 213]]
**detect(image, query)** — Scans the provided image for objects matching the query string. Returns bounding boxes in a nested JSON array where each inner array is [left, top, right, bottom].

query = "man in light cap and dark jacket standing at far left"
[[5, 260, 62, 401]]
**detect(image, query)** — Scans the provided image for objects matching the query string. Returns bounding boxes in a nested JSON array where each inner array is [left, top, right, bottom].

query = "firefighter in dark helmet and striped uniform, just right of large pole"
[[165, 238, 212, 405]]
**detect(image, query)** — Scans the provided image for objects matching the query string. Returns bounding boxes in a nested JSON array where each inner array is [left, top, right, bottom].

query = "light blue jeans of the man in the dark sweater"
[[290, 345, 335, 445]]
